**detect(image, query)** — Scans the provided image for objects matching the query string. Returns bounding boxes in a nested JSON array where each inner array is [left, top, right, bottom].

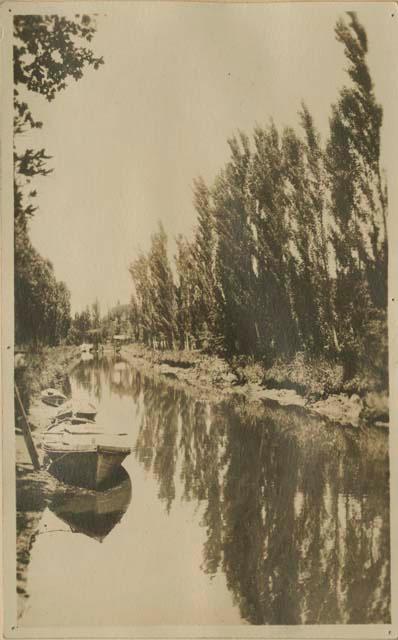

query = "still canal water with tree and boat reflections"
[[19, 358, 390, 627]]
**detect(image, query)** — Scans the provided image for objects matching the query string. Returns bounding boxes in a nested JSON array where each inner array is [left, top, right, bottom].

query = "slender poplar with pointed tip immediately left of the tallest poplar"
[[282, 105, 338, 353]]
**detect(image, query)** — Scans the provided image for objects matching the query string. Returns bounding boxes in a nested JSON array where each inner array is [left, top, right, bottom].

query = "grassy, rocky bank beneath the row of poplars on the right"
[[122, 344, 388, 426]]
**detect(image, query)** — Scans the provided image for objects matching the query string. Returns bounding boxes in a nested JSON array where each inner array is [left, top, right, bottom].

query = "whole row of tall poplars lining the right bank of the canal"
[[130, 12, 387, 374]]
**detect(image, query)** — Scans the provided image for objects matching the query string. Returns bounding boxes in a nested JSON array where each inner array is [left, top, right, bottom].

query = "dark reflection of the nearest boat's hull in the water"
[[48, 467, 131, 542]]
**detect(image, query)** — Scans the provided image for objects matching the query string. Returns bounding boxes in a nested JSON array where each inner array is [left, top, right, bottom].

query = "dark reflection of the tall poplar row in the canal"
[[132, 372, 390, 624]]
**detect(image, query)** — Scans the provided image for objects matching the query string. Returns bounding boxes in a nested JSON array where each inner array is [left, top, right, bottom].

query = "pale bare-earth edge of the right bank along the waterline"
[[121, 345, 388, 428]]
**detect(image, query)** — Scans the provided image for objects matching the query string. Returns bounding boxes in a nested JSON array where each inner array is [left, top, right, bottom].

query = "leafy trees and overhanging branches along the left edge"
[[13, 15, 103, 345]]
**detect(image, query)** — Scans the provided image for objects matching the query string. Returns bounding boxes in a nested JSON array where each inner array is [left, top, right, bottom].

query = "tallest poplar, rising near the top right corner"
[[326, 12, 387, 348]]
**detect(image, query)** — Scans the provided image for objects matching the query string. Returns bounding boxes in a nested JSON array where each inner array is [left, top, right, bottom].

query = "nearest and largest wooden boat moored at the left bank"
[[43, 421, 131, 489]]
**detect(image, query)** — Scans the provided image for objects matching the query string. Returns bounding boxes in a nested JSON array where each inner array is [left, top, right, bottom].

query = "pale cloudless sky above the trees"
[[21, 2, 398, 312]]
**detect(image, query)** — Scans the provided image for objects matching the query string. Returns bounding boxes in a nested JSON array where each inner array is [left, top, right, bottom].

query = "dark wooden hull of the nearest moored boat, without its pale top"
[[46, 445, 131, 489]]
